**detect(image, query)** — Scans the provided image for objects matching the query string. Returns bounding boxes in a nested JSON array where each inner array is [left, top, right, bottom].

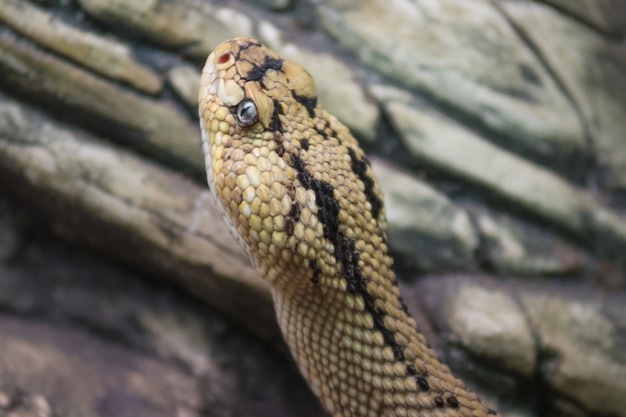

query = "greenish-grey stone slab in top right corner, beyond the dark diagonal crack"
[[502, 1, 626, 191]]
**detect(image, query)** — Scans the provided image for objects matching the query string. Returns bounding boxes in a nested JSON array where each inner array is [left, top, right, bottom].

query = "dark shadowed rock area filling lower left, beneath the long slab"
[[0, 208, 323, 417]]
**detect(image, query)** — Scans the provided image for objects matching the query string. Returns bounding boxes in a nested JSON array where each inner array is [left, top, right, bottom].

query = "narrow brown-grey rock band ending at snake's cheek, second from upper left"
[[0, 31, 204, 172]]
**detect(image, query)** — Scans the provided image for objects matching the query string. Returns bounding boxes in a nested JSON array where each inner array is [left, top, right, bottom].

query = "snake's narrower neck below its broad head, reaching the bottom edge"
[[272, 262, 496, 417]]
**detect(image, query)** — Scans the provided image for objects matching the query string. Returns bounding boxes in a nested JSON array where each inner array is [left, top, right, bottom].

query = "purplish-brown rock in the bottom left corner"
[[0, 316, 201, 417]]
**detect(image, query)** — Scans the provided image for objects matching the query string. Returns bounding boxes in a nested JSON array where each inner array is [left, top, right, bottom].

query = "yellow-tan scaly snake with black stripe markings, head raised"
[[199, 38, 498, 417]]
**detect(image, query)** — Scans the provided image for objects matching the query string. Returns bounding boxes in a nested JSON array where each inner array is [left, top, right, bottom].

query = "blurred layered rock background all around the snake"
[[0, 0, 626, 417]]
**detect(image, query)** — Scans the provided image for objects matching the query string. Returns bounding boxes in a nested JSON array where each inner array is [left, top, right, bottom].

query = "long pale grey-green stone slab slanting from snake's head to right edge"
[[371, 85, 626, 251]]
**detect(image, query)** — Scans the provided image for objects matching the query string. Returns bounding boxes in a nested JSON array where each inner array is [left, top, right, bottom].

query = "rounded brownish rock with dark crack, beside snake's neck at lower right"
[[409, 275, 626, 415]]
